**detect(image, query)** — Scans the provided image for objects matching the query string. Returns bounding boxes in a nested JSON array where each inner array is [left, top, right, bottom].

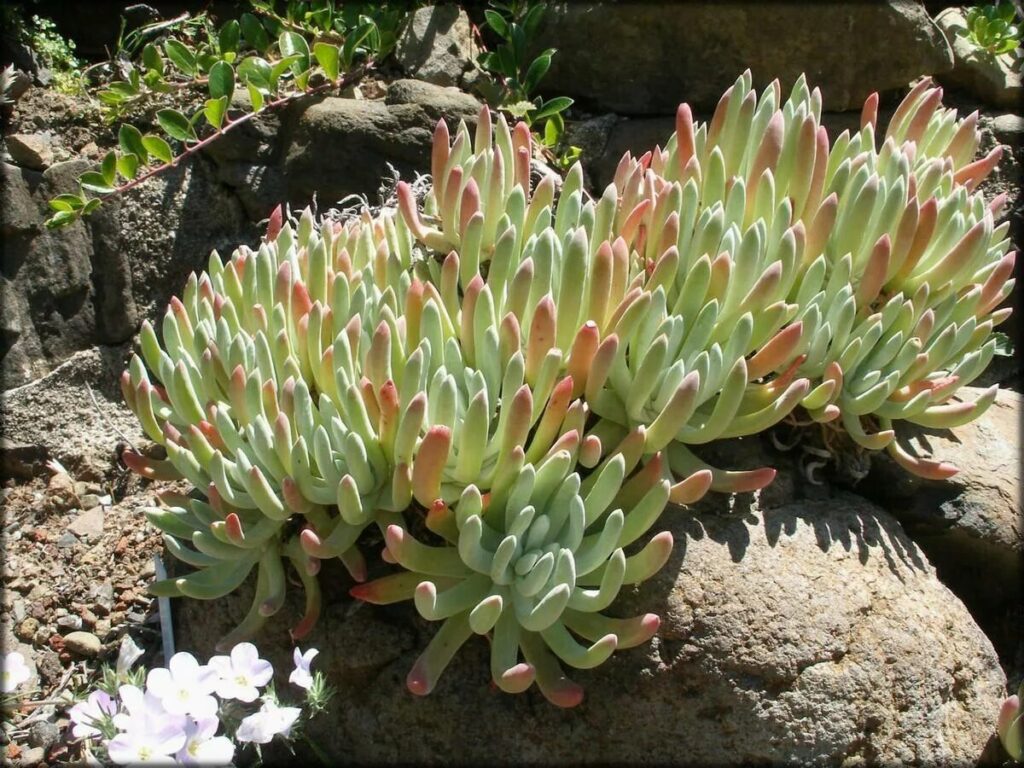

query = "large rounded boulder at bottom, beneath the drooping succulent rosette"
[[177, 495, 1006, 765]]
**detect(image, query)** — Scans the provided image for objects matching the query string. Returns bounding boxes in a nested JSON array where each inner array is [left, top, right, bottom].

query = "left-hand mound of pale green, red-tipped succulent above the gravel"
[[122, 196, 675, 645]]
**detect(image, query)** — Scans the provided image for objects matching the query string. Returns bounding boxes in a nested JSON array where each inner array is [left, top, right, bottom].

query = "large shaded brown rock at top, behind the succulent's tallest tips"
[[536, 0, 952, 115]]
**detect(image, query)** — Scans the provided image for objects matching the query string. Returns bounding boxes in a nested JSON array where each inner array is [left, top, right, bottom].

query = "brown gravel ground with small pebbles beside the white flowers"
[[0, 465, 183, 766]]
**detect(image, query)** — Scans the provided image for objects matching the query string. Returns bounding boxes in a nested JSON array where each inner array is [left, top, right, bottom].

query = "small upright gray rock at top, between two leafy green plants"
[[394, 5, 475, 86]]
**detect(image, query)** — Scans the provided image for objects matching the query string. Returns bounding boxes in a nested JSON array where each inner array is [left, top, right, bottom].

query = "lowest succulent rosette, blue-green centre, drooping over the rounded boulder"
[[352, 439, 672, 707]]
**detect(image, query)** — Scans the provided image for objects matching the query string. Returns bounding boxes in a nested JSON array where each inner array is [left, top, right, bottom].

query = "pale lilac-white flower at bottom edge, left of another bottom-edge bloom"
[[106, 685, 185, 765]]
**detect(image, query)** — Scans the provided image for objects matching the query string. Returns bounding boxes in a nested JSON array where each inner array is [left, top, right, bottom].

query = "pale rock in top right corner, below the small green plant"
[[935, 8, 1024, 110]]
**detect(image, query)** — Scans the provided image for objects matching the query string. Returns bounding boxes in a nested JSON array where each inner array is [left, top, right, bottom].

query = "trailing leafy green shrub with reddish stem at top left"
[[46, 6, 393, 227]]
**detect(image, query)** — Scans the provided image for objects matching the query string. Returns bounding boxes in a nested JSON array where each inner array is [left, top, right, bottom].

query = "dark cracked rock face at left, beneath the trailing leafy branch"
[[0, 160, 255, 388]]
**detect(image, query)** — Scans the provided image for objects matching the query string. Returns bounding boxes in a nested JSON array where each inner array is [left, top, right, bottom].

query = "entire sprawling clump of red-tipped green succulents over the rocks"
[[122, 73, 1014, 706]]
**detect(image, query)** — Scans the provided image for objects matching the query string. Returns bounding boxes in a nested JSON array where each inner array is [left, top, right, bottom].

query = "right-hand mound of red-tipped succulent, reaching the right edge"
[[399, 72, 1015, 481]]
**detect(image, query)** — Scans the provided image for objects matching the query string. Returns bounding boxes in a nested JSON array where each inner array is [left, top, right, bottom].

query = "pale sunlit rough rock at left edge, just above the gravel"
[[0, 345, 145, 479]]
